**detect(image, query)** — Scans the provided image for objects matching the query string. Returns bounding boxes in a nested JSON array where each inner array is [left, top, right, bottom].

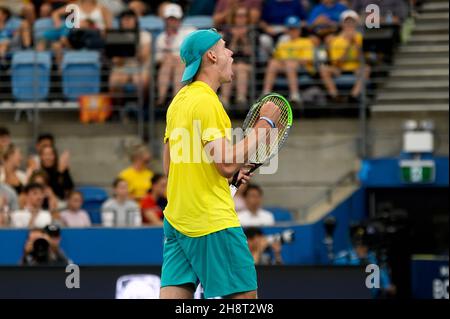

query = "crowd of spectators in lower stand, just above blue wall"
[[0, 127, 275, 229]]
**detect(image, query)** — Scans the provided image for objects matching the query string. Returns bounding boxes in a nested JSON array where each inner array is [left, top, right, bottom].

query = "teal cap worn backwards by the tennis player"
[[180, 29, 222, 83]]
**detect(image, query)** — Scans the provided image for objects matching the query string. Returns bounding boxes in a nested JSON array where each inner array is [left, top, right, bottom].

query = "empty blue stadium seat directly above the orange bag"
[[62, 50, 101, 100]]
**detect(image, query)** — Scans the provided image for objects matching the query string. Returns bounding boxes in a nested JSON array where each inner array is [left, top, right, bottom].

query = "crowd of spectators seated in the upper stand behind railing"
[[0, 0, 416, 107]]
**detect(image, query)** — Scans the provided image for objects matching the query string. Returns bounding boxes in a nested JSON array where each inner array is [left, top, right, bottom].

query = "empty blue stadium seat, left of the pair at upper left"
[[11, 50, 52, 101]]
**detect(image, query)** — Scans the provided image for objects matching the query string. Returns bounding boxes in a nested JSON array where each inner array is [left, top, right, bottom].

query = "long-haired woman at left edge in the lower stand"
[[0, 144, 31, 194]]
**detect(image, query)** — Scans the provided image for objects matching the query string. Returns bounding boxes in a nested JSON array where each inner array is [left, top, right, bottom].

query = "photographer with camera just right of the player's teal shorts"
[[244, 227, 283, 265]]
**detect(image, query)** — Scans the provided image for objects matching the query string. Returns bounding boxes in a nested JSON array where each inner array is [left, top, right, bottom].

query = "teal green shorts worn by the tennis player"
[[161, 220, 257, 298]]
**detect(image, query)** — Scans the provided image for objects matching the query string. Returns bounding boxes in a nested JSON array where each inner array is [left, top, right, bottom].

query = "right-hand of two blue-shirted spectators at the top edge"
[[308, 0, 347, 38]]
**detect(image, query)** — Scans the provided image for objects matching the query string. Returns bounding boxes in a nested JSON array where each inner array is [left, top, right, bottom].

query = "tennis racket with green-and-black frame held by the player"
[[230, 93, 292, 197]]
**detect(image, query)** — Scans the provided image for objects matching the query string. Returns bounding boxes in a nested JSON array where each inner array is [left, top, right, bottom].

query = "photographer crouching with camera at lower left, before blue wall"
[[21, 225, 70, 266]]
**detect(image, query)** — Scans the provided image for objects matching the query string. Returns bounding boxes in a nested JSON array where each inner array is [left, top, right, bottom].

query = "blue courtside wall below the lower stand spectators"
[[0, 157, 449, 266]]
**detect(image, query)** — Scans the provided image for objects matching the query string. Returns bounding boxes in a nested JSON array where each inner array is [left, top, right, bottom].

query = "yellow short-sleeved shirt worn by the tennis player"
[[164, 81, 240, 237]]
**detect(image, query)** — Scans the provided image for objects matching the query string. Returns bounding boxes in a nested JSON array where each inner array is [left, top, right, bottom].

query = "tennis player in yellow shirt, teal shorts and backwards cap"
[[160, 29, 280, 299]]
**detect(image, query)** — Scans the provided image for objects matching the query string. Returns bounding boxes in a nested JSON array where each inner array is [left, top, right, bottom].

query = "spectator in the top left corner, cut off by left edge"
[[0, 6, 31, 62]]
